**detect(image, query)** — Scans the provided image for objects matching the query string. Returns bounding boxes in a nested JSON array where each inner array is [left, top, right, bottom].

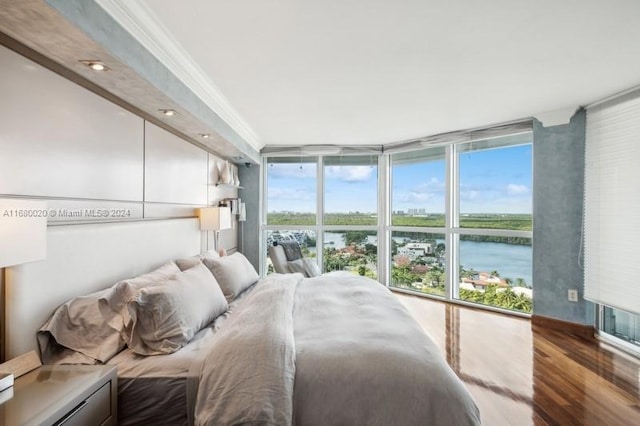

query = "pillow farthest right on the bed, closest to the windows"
[[202, 252, 260, 302]]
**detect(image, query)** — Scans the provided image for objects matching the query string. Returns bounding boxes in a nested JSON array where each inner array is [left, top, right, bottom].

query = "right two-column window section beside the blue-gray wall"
[[389, 133, 533, 313]]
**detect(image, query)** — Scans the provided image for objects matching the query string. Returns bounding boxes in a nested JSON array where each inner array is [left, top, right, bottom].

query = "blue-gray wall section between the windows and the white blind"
[[533, 110, 594, 325]]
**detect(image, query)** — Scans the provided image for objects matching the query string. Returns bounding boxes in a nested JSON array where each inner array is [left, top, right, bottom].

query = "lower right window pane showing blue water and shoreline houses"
[[459, 235, 533, 313]]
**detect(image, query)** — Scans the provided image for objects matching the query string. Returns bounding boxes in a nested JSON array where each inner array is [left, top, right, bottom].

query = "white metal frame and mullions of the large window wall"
[[259, 122, 535, 317]]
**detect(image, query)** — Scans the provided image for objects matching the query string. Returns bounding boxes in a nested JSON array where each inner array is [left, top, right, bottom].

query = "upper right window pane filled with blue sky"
[[458, 133, 532, 231]]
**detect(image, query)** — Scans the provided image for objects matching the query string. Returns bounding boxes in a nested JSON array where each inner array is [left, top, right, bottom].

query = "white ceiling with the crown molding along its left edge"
[[97, 0, 640, 145]]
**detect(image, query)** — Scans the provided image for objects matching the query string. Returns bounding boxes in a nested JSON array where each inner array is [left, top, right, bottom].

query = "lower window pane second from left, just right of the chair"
[[323, 231, 378, 279]]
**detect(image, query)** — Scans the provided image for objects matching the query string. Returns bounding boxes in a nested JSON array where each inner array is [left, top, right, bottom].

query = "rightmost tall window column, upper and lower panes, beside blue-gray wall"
[[453, 134, 533, 312]]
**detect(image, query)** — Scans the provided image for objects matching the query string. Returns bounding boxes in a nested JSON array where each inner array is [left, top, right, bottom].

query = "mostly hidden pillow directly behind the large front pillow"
[[98, 262, 180, 341]]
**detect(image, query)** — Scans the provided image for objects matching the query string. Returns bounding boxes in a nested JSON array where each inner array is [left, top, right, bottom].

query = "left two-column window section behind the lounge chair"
[[265, 154, 379, 278]]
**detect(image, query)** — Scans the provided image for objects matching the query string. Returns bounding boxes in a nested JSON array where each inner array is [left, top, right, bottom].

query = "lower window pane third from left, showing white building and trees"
[[390, 232, 447, 296]]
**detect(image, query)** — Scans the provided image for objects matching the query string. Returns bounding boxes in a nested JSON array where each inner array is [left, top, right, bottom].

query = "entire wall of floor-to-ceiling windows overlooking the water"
[[263, 126, 533, 313]]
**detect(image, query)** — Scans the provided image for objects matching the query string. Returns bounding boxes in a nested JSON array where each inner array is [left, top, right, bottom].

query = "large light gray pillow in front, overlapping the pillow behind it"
[[127, 264, 228, 355]]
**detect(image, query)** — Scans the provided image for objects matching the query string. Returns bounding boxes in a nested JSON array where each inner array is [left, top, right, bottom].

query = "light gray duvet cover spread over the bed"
[[195, 274, 480, 426]]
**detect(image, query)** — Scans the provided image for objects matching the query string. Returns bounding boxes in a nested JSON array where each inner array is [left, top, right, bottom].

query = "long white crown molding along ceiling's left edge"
[[95, 0, 264, 151]]
